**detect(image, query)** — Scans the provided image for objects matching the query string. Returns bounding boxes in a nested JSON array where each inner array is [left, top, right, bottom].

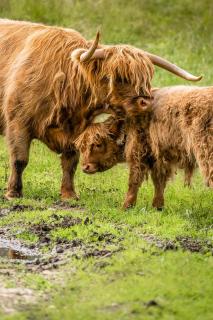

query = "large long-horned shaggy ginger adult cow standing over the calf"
[[0, 20, 200, 199]]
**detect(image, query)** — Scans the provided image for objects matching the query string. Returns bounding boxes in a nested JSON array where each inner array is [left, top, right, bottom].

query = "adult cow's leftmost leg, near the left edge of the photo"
[[5, 123, 31, 200]]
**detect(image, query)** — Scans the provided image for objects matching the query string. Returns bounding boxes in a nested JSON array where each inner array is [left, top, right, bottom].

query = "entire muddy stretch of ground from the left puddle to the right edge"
[[0, 201, 213, 314]]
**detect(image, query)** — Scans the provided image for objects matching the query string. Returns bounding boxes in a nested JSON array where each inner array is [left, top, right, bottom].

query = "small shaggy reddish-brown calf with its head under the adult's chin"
[[76, 86, 213, 208]]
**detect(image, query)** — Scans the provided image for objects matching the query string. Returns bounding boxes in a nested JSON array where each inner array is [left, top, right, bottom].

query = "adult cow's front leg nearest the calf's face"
[[61, 150, 79, 200]]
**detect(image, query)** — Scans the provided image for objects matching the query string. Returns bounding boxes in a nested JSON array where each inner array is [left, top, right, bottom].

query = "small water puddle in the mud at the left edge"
[[0, 238, 39, 262]]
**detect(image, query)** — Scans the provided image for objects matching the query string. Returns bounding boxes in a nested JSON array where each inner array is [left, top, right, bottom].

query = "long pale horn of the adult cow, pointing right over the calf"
[[145, 52, 202, 81]]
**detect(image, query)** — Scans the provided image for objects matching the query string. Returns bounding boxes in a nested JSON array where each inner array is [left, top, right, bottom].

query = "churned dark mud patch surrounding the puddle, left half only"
[[0, 205, 123, 272]]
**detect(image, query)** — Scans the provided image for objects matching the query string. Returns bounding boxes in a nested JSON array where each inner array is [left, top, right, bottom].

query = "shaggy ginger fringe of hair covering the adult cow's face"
[[80, 45, 154, 103]]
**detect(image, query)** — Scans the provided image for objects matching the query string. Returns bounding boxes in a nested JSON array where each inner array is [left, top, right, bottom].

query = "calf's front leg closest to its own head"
[[123, 163, 146, 209]]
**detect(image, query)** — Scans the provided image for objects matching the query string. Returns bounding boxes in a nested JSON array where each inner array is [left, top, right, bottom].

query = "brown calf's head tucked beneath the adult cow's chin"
[[75, 113, 125, 174]]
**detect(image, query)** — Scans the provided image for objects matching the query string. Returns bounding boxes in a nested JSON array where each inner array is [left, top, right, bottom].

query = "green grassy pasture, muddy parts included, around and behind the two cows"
[[0, 0, 213, 320]]
